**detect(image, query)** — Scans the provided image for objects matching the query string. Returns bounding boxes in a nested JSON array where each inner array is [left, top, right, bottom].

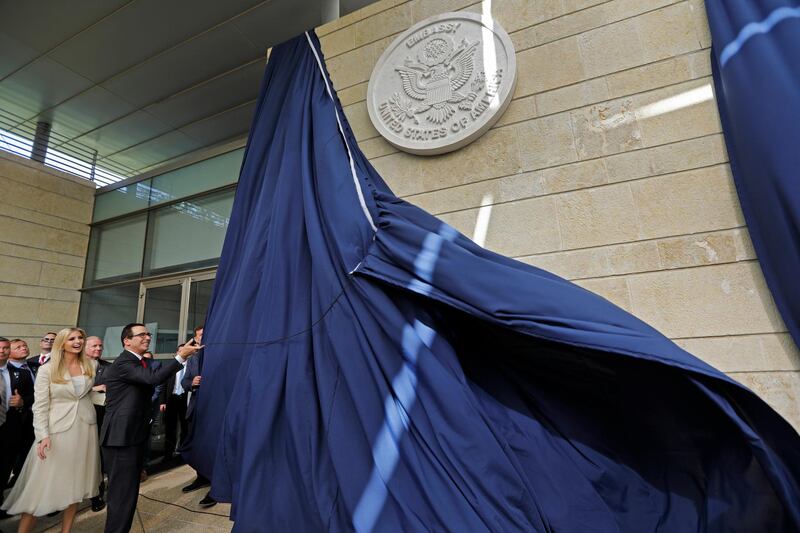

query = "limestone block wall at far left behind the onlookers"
[[0, 151, 95, 353]]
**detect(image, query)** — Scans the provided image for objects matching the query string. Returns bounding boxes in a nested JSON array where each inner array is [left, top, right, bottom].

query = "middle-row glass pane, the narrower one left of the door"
[[86, 213, 147, 286]]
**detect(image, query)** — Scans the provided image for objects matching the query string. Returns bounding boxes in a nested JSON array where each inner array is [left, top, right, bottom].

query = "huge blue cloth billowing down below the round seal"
[[186, 33, 800, 532]]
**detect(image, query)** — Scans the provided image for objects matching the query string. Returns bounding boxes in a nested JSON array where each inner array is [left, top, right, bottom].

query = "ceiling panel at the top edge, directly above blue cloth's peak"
[[233, 0, 322, 52]]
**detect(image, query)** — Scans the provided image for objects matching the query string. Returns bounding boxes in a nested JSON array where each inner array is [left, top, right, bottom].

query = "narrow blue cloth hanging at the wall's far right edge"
[[706, 0, 800, 346]]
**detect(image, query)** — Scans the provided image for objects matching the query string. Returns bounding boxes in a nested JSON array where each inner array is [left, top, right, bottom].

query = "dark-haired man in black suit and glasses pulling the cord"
[[95, 323, 202, 533]]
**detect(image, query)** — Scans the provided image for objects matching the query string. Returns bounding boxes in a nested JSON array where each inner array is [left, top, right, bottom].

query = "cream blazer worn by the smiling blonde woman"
[[33, 361, 97, 442]]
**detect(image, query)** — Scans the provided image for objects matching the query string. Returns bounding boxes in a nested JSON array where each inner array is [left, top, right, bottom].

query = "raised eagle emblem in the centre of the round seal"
[[392, 36, 478, 124]]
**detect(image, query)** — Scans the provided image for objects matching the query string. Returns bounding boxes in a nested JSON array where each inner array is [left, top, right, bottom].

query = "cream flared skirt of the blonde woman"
[[3, 419, 101, 516]]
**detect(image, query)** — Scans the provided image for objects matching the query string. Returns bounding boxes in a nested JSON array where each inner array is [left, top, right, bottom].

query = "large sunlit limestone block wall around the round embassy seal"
[[317, 0, 800, 429]]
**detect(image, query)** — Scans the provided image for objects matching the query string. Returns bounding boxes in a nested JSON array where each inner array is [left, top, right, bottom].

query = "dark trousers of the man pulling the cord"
[[103, 445, 144, 533]]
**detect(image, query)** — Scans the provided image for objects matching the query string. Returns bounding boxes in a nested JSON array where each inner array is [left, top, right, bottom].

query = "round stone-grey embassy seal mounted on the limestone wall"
[[367, 12, 517, 155]]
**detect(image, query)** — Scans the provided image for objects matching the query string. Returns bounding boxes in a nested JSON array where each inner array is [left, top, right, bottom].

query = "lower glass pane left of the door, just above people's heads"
[[78, 283, 139, 359]]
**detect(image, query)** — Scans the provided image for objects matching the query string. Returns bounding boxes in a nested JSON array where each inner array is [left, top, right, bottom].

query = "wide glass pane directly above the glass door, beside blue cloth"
[[144, 190, 235, 275]]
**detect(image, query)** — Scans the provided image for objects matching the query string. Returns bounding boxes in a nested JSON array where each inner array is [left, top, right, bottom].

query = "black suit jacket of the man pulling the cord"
[[95, 351, 181, 446]]
